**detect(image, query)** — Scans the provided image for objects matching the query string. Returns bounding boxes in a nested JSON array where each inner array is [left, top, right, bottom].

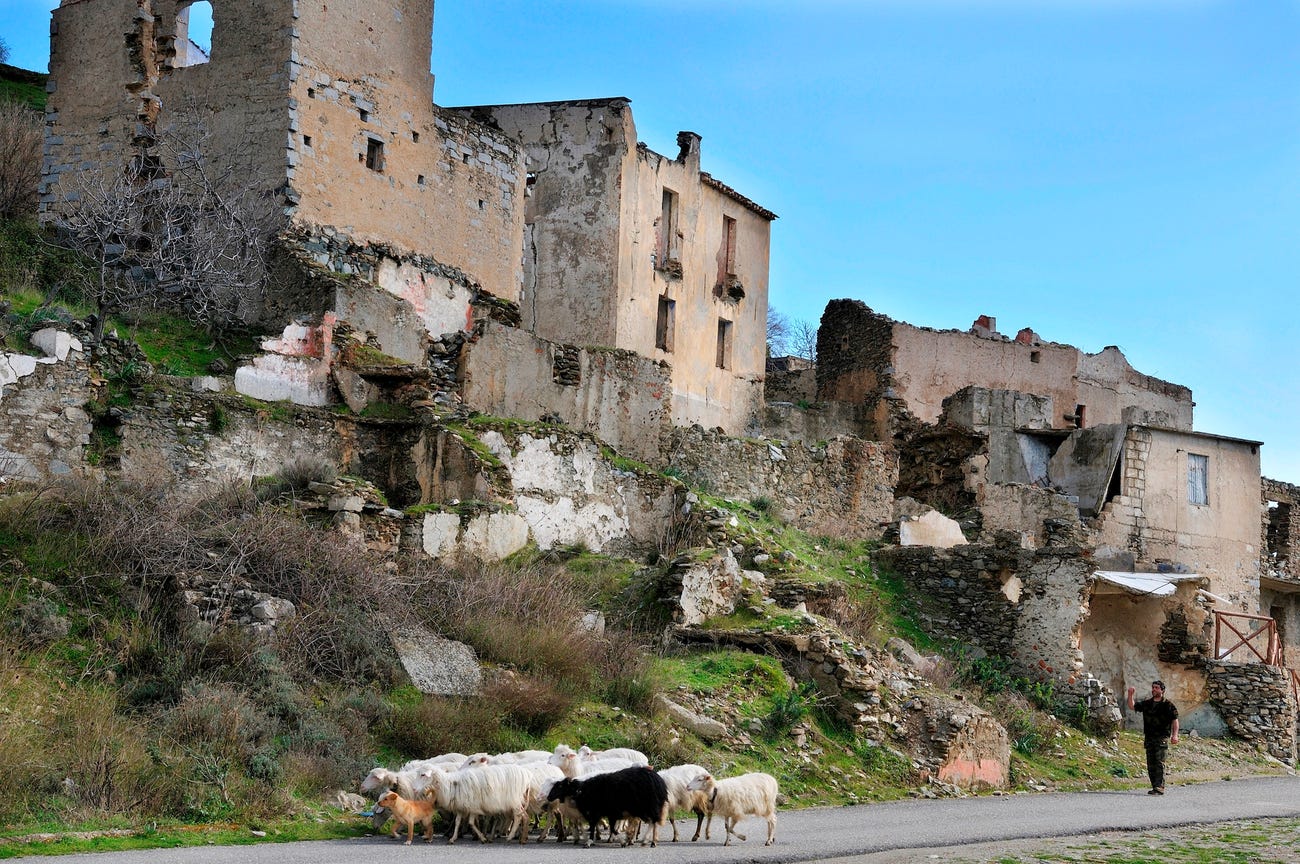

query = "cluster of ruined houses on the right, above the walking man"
[[800, 300, 1300, 759]]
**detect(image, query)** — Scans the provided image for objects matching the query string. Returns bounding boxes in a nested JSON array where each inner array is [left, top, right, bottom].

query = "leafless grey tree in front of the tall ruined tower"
[[55, 127, 280, 338]]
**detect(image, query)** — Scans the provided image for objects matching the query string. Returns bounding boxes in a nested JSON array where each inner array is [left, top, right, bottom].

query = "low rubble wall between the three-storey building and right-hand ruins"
[[660, 427, 897, 539]]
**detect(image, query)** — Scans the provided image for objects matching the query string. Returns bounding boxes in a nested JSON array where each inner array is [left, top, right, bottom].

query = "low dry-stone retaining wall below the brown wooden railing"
[[1205, 660, 1296, 765]]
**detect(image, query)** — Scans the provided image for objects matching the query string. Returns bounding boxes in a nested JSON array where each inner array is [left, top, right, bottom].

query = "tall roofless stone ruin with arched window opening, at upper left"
[[42, 0, 525, 306]]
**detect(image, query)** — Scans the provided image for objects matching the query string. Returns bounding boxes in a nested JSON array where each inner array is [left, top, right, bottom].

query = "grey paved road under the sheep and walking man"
[[15, 777, 1300, 864]]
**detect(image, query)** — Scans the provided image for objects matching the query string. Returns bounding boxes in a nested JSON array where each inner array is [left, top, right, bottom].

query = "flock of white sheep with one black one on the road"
[[360, 744, 777, 846]]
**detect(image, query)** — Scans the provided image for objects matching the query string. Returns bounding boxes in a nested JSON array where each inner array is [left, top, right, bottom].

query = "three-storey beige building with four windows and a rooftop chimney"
[[460, 97, 776, 434]]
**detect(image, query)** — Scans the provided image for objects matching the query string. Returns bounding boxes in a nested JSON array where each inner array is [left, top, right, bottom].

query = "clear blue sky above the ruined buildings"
[[0, 0, 1300, 483]]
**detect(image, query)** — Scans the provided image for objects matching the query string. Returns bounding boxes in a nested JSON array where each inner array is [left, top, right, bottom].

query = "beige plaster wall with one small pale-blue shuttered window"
[[1097, 426, 1268, 605]]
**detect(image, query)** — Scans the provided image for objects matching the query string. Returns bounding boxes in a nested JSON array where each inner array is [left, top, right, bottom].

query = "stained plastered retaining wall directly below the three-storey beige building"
[[462, 321, 672, 461]]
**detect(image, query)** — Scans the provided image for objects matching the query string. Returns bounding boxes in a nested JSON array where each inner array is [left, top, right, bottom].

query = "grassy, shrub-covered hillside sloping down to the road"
[[0, 219, 1284, 858]]
